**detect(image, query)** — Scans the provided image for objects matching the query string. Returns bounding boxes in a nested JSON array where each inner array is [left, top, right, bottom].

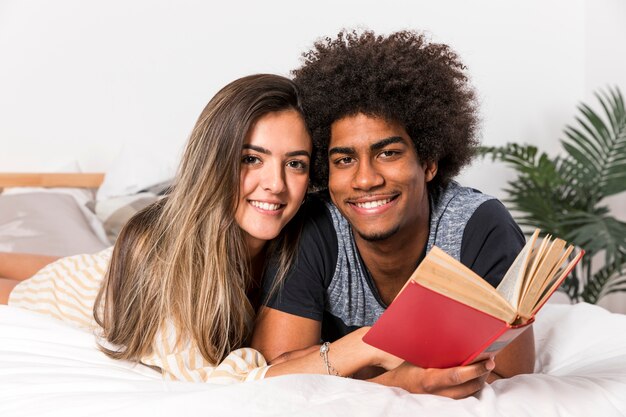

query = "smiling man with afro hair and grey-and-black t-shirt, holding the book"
[[253, 32, 534, 397]]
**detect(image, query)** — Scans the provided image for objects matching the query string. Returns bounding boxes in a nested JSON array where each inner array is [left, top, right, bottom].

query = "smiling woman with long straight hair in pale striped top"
[[1, 75, 312, 380]]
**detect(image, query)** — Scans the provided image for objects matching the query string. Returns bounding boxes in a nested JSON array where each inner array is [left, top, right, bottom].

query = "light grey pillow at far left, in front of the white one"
[[0, 192, 108, 256]]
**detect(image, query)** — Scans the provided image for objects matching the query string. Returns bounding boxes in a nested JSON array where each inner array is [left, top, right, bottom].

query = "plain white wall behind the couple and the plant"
[[0, 0, 626, 306]]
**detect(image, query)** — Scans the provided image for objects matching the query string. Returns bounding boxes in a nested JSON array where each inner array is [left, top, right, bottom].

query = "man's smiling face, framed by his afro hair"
[[328, 113, 437, 241]]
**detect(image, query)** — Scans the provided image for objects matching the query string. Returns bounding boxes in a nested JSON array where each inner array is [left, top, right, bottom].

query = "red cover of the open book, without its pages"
[[363, 281, 530, 368]]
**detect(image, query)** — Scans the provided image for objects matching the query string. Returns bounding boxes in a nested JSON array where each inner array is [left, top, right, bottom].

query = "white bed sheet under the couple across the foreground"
[[0, 304, 626, 417]]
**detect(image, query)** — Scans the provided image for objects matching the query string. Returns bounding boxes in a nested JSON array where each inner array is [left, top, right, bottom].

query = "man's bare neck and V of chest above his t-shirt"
[[354, 210, 429, 305]]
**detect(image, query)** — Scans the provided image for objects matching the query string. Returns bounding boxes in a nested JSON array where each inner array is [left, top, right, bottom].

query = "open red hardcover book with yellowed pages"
[[363, 230, 584, 368]]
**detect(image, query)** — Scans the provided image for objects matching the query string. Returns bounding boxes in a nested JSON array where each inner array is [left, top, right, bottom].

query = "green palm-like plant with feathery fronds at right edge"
[[479, 88, 626, 304]]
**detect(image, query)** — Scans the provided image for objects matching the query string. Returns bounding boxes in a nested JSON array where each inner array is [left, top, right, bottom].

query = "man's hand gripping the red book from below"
[[370, 359, 496, 399]]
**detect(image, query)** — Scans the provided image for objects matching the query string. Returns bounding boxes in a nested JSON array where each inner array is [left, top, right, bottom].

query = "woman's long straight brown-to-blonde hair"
[[94, 74, 302, 363]]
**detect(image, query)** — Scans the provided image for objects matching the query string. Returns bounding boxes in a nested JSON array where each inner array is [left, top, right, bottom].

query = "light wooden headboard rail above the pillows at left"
[[0, 173, 104, 188]]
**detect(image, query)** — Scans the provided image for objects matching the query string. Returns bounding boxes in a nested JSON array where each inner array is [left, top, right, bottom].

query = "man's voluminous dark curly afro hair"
[[293, 30, 478, 189]]
